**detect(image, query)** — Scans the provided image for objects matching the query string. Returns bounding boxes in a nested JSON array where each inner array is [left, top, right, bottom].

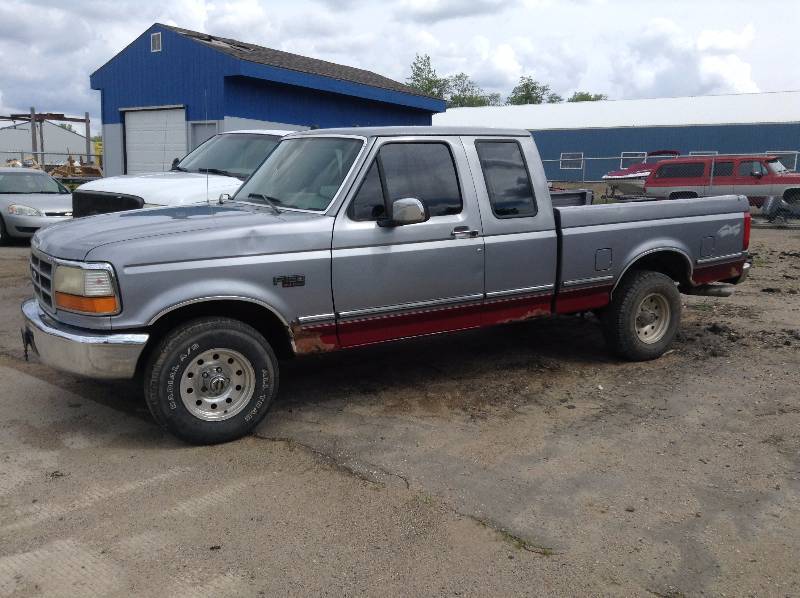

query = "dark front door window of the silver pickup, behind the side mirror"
[[347, 141, 463, 221]]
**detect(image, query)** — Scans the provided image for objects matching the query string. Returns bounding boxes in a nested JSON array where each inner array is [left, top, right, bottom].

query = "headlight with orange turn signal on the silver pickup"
[[53, 264, 120, 316]]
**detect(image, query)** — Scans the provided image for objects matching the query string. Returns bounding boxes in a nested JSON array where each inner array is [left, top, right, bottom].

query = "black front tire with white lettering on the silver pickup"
[[144, 318, 279, 444]]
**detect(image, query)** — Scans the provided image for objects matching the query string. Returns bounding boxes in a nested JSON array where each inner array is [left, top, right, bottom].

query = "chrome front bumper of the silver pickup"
[[22, 299, 149, 378]]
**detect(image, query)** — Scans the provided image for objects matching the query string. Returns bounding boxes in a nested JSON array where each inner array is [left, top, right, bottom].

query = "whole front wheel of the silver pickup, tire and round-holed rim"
[[144, 318, 278, 444]]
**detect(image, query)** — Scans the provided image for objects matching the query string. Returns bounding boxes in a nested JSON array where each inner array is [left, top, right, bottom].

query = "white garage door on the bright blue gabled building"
[[125, 108, 186, 174]]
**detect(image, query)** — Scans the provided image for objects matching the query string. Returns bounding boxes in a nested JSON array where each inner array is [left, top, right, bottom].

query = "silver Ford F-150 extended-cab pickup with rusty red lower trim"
[[22, 127, 750, 443]]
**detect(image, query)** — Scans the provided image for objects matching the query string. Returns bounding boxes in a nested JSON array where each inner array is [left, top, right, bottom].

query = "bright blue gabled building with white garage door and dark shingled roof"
[[90, 23, 445, 175]]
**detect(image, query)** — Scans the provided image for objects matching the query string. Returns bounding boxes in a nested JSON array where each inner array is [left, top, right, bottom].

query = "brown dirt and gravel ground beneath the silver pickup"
[[0, 229, 800, 597]]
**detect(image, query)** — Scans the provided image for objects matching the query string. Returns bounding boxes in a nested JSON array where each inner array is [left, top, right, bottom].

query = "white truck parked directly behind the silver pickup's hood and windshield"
[[72, 130, 293, 218]]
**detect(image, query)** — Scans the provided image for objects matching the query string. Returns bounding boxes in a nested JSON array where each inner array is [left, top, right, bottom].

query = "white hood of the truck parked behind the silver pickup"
[[77, 170, 242, 206]]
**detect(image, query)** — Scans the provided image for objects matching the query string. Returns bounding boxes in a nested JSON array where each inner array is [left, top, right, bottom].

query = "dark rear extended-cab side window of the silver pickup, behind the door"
[[475, 140, 536, 218]]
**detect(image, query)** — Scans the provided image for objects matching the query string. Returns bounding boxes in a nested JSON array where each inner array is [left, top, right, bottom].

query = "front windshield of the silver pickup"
[[233, 137, 364, 211]]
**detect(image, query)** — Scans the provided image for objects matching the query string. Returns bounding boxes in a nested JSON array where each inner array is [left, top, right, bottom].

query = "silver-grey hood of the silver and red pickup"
[[31, 202, 332, 263]]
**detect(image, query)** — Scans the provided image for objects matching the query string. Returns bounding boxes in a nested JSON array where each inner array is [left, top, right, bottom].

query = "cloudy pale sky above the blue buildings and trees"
[[0, 0, 800, 130]]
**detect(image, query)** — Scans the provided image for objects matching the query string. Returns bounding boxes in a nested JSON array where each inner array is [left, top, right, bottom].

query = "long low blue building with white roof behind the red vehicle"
[[433, 91, 800, 181]]
